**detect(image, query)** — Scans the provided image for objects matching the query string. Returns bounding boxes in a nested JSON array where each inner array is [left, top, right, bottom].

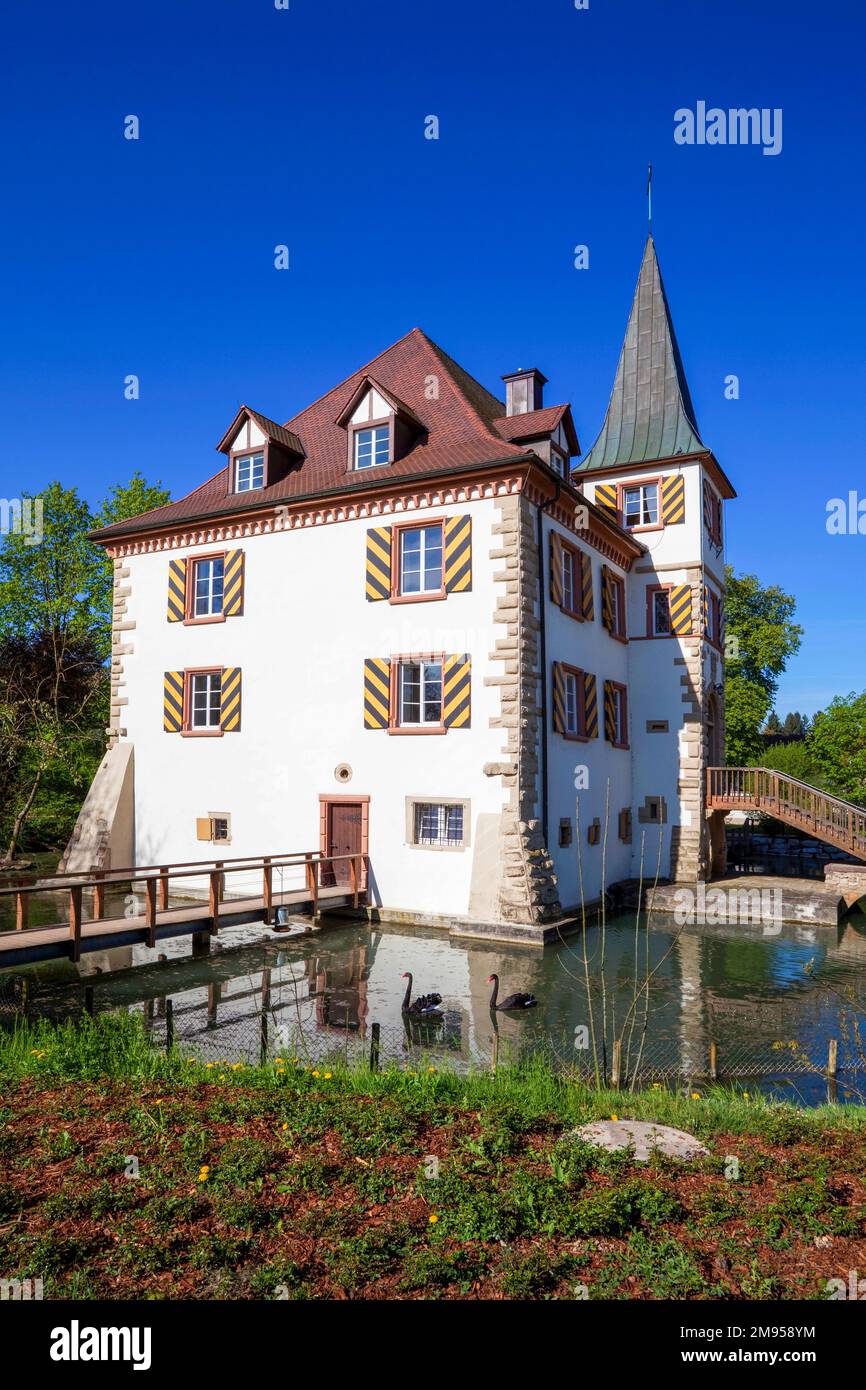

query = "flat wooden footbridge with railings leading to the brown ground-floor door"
[[0, 851, 370, 970]]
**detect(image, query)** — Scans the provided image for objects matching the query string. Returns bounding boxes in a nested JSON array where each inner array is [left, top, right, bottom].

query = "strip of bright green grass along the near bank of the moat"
[[6, 1015, 866, 1139]]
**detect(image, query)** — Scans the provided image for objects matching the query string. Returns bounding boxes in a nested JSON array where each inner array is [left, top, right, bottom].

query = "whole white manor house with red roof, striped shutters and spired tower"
[[65, 238, 735, 934]]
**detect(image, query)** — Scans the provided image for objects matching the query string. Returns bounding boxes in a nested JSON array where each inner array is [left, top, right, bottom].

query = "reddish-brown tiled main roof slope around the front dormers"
[[95, 328, 530, 539]]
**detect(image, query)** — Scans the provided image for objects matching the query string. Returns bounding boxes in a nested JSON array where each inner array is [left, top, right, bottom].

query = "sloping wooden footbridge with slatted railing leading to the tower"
[[706, 767, 866, 859]]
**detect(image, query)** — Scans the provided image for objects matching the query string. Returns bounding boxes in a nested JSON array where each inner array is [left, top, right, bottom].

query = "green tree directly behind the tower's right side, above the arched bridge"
[[726, 566, 803, 766]]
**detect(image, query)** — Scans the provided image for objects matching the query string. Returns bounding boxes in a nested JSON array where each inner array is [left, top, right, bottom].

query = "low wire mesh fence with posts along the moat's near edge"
[[0, 972, 866, 1088]]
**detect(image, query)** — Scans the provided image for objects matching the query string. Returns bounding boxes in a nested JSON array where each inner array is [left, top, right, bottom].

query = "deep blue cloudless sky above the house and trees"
[[0, 0, 866, 713]]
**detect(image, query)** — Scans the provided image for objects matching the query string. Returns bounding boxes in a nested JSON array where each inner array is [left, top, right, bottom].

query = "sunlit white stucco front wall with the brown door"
[[116, 500, 503, 913]]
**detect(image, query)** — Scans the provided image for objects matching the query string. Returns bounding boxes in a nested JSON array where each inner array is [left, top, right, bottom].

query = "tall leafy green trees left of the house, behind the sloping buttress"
[[0, 473, 168, 862]]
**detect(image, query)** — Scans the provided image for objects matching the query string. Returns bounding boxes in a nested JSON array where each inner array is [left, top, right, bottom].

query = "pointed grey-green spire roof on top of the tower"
[[573, 236, 708, 473]]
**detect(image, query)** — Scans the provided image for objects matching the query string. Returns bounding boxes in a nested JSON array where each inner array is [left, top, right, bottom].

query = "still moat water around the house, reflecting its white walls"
[[0, 889, 866, 1104]]
